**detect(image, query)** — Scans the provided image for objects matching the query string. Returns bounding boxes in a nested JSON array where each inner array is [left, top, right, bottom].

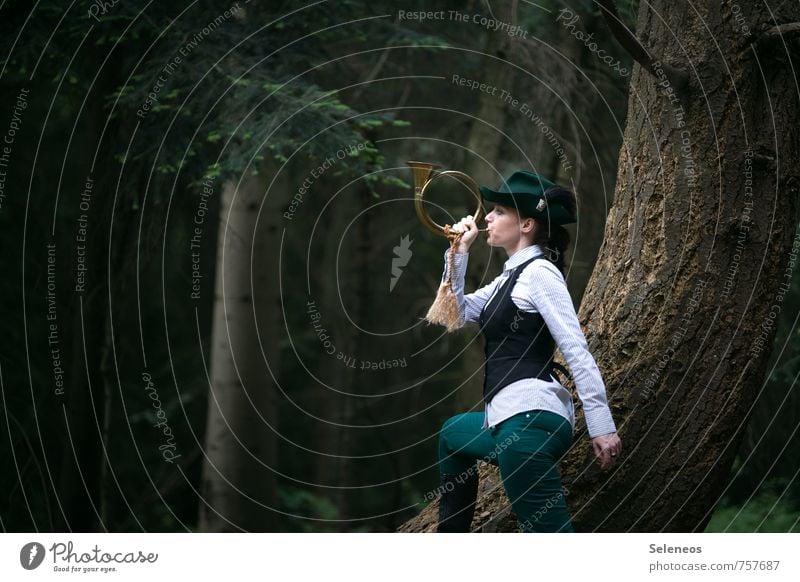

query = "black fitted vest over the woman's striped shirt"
[[479, 256, 563, 403]]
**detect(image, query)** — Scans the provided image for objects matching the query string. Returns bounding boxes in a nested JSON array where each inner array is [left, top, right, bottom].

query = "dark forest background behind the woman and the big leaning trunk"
[[0, 0, 800, 532]]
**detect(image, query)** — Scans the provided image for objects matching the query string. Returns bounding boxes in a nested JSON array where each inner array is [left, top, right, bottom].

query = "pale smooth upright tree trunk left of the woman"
[[198, 175, 280, 531]]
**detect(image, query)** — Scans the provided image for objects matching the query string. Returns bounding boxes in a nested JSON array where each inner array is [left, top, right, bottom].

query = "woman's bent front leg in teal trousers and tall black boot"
[[438, 412, 494, 533]]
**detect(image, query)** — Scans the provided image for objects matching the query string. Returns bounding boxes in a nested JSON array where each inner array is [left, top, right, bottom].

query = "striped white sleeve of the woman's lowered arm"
[[520, 261, 617, 438]]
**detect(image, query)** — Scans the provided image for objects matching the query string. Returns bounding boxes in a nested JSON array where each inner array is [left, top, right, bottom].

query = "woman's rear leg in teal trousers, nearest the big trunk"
[[494, 410, 575, 532]]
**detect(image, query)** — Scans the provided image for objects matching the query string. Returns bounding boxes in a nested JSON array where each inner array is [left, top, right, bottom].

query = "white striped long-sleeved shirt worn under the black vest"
[[442, 245, 617, 438]]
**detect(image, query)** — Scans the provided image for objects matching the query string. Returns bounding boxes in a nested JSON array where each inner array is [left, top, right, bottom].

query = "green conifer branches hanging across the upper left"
[[7, 1, 416, 207]]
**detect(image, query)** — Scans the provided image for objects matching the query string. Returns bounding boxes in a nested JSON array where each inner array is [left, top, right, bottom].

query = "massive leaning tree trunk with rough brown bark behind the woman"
[[402, 1, 800, 532]]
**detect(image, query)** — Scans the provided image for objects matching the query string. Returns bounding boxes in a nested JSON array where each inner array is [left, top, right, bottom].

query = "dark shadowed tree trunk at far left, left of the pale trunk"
[[54, 54, 122, 532]]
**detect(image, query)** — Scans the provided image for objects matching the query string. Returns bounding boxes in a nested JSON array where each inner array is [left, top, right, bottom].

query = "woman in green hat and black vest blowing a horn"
[[438, 170, 622, 532]]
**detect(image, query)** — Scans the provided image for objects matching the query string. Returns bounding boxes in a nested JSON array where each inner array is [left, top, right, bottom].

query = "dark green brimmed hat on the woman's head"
[[480, 170, 578, 224]]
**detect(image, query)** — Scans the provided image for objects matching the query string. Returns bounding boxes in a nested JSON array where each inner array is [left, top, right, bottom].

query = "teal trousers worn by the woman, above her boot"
[[439, 410, 575, 532]]
